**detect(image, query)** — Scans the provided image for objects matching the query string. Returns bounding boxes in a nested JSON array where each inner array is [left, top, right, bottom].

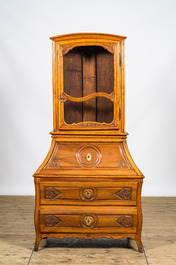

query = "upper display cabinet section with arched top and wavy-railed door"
[[51, 34, 125, 132]]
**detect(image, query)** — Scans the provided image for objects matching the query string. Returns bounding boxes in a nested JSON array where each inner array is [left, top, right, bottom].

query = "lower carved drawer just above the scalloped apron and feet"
[[40, 206, 137, 233]]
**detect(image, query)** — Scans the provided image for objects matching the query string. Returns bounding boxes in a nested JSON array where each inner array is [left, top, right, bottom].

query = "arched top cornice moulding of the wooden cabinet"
[[50, 33, 126, 41]]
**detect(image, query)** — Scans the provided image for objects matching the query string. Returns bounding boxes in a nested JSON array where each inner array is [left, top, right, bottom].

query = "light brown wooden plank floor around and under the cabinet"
[[0, 196, 176, 265]]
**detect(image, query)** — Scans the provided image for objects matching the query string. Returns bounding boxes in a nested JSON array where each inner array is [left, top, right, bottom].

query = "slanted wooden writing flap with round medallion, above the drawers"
[[41, 142, 133, 171]]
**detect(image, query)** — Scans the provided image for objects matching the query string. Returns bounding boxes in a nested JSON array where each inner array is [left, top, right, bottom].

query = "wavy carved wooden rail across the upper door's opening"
[[60, 92, 115, 102]]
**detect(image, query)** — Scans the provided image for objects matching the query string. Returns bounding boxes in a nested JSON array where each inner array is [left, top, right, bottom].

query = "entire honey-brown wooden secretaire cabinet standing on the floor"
[[34, 33, 143, 251]]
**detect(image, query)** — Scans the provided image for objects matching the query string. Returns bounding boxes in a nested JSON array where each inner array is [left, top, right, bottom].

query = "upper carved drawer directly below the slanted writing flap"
[[40, 181, 137, 205]]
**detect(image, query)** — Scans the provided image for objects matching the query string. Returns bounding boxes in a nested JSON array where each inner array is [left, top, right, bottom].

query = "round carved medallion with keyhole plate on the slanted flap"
[[76, 146, 102, 167]]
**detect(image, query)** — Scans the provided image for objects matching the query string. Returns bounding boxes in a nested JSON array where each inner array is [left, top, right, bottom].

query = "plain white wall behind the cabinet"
[[0, 0, 176, 196]]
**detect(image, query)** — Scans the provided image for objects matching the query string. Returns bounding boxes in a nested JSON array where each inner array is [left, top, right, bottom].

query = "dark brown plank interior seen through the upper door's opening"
[[63, 46, 114, 124]]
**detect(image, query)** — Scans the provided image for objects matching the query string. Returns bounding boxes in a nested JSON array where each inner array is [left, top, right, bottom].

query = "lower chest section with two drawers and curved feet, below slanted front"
[[35, 177, 142, 251]]
